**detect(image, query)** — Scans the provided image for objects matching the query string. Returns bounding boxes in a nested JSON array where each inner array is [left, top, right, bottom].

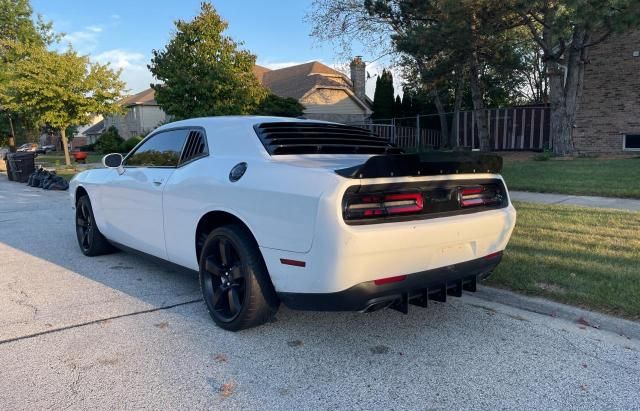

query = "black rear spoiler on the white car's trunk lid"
[[335, 152, 502, 178]]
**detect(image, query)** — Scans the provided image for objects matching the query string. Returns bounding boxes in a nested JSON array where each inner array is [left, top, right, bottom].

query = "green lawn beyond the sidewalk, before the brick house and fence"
[[502, 157, 640, 198]]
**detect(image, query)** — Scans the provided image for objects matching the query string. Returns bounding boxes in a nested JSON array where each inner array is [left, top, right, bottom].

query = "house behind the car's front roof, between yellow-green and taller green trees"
[[103, 88, 167, 140]]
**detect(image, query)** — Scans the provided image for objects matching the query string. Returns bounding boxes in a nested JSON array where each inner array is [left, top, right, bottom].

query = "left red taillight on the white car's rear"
[[345, 193, 424, 219]]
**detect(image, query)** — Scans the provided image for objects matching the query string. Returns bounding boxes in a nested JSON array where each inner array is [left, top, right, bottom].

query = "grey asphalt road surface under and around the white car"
[[0, 174, 640, 410]]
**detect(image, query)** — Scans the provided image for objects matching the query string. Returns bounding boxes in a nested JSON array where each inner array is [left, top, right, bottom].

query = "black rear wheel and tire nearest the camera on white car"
[[200, 225, 280, 331]]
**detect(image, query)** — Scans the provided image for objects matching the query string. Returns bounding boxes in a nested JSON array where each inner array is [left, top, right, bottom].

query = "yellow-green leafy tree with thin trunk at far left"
[[0, 47, 125, 166]]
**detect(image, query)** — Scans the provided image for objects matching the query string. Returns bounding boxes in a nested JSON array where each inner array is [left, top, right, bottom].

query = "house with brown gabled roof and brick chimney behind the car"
[[254, 57, 372, 123]]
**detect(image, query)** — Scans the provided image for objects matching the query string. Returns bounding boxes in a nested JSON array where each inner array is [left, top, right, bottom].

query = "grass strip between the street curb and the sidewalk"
[[487, 203, 640, 320]]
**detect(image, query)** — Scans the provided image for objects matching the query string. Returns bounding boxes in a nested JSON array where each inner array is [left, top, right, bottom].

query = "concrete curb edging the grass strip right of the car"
[[473, 286, 640, 340]]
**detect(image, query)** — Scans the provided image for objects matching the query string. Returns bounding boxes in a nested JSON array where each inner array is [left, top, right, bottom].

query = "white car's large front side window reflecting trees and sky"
[[125, 129, 189, 167]]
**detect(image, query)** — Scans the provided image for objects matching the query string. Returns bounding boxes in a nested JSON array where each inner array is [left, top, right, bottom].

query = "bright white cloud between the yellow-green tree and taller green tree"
[[92, 49, 153, 94]]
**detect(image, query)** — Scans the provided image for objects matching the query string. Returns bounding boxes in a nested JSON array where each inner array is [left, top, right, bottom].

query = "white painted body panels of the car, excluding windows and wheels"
[[69, 116, 516, 293]]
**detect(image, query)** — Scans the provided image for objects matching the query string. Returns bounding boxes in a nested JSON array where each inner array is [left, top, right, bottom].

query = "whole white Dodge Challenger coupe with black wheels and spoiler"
[[69, 116, 516, 331]]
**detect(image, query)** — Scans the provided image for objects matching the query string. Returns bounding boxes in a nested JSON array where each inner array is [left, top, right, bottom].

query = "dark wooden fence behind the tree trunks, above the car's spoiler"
[[353, 106, 551, 151]]
